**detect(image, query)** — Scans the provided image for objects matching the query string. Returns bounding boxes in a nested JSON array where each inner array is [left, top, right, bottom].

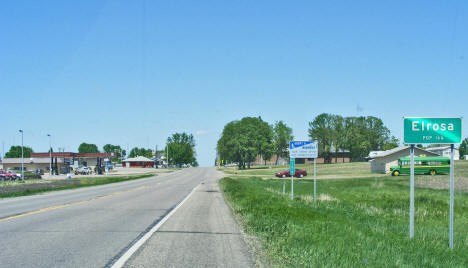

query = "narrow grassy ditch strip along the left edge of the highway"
[[0, 174, 157, 198]]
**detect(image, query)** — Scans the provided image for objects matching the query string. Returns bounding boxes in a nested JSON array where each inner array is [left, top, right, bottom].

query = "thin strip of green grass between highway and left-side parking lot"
[[0, 174, 157, 198]]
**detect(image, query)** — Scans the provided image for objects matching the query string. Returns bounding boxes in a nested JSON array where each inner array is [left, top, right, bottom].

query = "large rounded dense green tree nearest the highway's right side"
[[217, 117, 274, 169]]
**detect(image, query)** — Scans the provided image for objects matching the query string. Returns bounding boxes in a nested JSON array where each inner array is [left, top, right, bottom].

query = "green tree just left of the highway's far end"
[[165, 132, 198, 166]]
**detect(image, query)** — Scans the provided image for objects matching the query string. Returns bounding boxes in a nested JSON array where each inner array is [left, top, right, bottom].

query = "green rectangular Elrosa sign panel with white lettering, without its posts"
[[403, 117, 462, 144]]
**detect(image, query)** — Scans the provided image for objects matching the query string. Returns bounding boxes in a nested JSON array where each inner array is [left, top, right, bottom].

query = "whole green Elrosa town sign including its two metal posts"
[[403, 117, 462, 248]]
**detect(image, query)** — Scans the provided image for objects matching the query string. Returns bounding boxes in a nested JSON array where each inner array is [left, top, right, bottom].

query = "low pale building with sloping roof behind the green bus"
[[370, 146, 438, 173]]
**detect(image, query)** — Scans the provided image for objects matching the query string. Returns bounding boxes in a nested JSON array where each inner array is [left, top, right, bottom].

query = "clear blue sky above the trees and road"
[[0, 0, 468, 166]]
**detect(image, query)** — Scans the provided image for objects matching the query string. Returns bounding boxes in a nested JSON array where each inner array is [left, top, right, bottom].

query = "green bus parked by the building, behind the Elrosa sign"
[[390, 156, 450, 176]]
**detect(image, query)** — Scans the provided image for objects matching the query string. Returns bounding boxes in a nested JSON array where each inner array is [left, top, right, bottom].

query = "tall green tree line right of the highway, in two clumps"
[[217, 113, 399, 169]]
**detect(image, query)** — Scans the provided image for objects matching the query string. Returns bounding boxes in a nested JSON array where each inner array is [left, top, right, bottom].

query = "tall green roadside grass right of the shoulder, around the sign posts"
[[220, 178, 468, 267]]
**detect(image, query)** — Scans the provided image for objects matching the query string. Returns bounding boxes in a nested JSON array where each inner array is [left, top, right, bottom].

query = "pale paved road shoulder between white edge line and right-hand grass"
[[125, 169, 255, 267]]
